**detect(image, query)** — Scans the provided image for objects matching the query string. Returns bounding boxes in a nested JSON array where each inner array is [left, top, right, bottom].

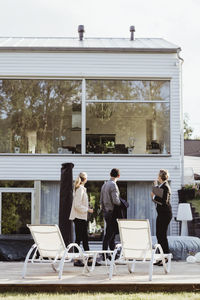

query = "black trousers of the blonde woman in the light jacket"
[[74, 218, 89, 252]]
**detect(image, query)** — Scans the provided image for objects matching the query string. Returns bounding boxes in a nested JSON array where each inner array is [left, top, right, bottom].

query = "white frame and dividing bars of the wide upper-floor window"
[[0, 76, 172, 157]]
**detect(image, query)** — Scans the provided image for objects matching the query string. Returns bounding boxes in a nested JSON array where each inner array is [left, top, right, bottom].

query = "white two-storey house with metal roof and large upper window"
[[0, 27, 183, 239]]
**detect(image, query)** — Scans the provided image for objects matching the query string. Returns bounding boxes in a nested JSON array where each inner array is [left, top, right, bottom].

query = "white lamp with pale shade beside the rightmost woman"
[[176, 203, 192, 236]]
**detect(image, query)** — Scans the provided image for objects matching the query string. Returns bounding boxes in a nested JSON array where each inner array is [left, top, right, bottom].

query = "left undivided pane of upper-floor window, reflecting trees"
[[0, 79, 82, 154]]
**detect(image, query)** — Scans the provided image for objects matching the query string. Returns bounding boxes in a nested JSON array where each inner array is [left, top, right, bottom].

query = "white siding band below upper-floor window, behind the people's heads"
[[0, 155, 180, 181]]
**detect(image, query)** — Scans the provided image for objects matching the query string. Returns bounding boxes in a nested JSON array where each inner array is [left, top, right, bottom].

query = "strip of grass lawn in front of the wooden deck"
[[0, 293, 200, 300]]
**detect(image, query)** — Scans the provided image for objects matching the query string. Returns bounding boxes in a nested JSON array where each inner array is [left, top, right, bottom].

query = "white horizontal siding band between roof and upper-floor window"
[[0, 52, 178, 78]]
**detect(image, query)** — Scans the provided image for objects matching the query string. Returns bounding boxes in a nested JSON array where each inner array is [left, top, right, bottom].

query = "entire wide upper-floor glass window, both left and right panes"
[[0, 79, 170, 155]]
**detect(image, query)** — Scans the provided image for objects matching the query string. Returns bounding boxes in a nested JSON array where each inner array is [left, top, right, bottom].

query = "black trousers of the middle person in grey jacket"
[[103, 211, 116, 250]]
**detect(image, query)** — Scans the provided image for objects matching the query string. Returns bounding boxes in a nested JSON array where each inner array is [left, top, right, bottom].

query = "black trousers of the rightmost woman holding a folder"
[[156, 214, 172, 253]]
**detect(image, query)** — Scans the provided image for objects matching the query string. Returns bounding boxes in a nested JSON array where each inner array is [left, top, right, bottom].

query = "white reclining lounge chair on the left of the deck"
[[22, 225, 89, 279]]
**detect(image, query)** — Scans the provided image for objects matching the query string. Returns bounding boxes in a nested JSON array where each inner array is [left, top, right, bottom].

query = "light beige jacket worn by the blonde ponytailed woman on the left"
[[69, 185, 88, 220]]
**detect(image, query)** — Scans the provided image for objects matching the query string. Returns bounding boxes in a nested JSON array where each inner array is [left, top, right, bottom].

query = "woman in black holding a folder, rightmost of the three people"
[[151, 169, 172, 265]]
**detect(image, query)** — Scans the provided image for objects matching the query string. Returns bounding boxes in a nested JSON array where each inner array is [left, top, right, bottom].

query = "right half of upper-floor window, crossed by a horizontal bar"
[[86, 80, 170, 154]]
